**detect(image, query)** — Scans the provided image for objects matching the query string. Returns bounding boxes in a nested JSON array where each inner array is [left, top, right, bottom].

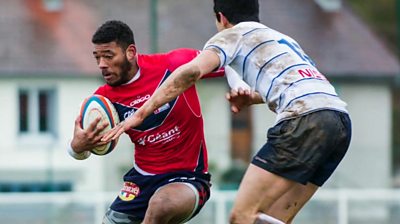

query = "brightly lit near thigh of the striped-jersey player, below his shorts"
[[232, 164, 295, 220]]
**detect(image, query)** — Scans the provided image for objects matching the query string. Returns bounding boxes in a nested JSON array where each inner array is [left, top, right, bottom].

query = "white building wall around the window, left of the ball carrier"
[[0, 78, 132, 191]]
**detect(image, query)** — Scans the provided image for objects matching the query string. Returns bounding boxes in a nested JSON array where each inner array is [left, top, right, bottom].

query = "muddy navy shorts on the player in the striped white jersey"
[[252, 110, 351, 186]]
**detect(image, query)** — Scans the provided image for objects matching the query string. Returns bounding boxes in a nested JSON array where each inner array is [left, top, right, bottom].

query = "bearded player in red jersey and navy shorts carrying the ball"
[[69, 21, 236, 224]]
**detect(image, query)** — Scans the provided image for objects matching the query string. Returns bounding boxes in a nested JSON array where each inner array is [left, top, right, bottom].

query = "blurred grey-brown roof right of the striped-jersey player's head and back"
[[260, 0, 400, 76]]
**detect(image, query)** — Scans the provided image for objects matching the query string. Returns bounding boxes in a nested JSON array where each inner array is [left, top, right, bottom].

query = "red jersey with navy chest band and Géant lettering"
[[95, 49, 223, 175]]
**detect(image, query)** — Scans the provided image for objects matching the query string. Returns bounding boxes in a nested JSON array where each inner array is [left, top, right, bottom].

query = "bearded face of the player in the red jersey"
[[93, 42, 134, 86]]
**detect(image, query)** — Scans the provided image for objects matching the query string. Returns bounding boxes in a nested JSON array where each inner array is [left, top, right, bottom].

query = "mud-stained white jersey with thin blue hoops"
[[204, 22, 347, 122]]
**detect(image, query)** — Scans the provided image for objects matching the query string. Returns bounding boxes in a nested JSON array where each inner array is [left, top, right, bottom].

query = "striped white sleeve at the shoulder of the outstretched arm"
[[203, 29, 242, 68]]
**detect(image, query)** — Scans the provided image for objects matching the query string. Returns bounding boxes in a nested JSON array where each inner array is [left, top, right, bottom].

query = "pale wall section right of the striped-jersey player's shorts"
[[328, 84, 392, 188]]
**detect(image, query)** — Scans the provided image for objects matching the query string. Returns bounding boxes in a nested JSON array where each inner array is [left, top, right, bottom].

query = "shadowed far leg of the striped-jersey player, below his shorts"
[[263, 183, 318, 223]]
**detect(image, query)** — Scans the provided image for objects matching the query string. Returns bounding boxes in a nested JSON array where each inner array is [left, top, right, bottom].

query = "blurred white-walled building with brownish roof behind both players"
[[0, 0, 400, 196]]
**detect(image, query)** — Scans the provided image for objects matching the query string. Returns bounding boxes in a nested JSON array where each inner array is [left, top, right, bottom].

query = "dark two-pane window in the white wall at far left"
[[18, 88, 56, 137]]
